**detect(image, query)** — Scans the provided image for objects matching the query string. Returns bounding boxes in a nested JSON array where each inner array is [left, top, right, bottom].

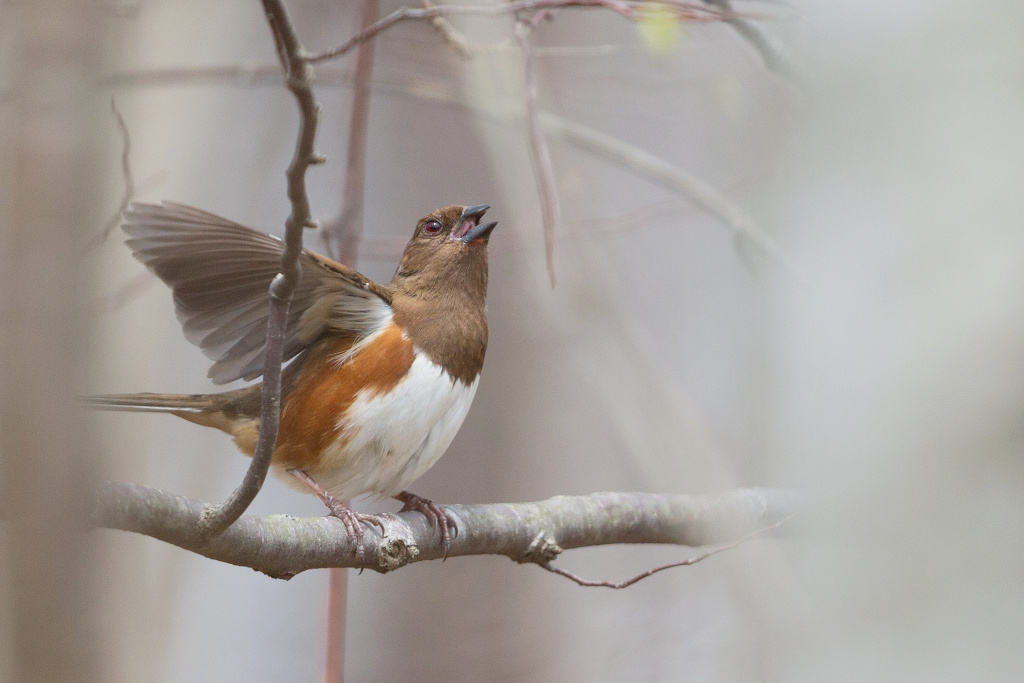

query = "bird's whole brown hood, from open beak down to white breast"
[[388, 205, 498, 383]]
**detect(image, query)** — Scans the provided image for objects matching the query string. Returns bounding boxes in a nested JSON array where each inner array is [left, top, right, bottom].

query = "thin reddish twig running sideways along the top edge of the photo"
[[310, 0, 734, 62]]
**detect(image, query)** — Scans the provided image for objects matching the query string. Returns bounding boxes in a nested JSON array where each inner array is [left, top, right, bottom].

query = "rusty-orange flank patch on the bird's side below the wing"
[[273, 323, 414, 470]]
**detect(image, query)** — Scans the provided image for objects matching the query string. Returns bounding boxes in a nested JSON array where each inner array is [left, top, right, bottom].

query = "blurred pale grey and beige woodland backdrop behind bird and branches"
[[0, 0, 1024, 682]]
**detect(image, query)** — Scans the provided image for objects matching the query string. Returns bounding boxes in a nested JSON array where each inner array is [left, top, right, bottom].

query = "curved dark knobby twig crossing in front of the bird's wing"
[[196, 0, 325, 536]]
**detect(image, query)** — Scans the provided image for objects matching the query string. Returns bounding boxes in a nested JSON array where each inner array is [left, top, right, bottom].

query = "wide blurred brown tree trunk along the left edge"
[[0, 1, 103, 681]]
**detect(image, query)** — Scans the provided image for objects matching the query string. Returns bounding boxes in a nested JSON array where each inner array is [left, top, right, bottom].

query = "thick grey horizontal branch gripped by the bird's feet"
[[93, 483, 799, 579]]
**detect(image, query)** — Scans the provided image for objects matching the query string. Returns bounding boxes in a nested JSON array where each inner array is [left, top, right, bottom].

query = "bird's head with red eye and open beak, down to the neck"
[[391, 204, 498, 297]]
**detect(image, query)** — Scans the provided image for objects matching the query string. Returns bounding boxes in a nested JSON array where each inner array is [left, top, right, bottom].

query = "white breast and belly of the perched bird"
[[310, 350, 480, 500]]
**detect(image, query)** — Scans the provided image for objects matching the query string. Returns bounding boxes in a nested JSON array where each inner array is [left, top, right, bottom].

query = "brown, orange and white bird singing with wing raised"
[[87, 201, 497, 560]]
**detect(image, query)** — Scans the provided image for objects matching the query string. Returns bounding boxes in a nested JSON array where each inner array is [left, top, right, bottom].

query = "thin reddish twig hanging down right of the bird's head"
[[515, 20, 562, 287]]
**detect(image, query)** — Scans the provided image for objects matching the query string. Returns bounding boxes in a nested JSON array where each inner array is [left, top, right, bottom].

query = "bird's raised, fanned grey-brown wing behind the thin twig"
[[122, 202, 392, 384]]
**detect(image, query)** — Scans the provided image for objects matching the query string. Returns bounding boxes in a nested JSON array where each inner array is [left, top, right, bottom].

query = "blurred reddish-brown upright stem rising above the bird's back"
[[324, 0, 378, 266]]
